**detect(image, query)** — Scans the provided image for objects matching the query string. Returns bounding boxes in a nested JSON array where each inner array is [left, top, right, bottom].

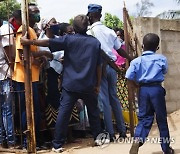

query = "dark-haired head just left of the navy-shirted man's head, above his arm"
[[59, 23, 74, 36]]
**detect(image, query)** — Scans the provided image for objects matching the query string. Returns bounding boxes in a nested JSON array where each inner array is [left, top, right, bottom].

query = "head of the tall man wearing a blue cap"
[[87, 4, 102, 25]]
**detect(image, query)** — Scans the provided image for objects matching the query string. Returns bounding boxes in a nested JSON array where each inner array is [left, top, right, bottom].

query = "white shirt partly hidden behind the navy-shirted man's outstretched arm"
[[38, 31, 64, 74]]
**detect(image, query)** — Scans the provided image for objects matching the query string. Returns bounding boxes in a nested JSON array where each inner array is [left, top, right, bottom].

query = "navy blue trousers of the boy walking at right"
[[135, 85, 170, 152]]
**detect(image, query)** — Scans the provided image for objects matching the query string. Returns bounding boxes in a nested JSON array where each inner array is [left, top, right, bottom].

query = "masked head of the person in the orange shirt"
[[28, 3, 41, 27]]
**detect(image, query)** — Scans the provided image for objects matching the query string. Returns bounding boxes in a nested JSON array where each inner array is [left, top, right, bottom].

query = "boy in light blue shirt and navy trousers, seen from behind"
[[126, 33, 174, 154]]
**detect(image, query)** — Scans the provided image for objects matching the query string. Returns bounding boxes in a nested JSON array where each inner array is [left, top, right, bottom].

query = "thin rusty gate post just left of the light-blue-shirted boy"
[[123, 4, 134, 137]]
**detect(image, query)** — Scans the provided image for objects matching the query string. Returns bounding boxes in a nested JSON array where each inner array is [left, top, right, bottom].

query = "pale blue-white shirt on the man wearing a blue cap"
[[87, 21, 121, 61]]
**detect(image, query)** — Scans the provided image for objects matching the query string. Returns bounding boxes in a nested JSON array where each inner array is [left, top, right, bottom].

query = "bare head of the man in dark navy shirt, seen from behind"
[[73, 14, 88, 34]]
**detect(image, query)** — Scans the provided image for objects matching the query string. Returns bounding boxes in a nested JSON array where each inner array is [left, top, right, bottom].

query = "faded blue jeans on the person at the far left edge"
[[0, 79, 15, 145]]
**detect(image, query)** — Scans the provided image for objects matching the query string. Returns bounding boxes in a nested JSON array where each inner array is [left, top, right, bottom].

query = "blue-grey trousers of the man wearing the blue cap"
[[99, 65, 126, 134]]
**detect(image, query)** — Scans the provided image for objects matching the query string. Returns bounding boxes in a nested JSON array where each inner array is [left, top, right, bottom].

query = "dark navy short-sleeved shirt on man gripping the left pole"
[[49, 34, 101, 93]]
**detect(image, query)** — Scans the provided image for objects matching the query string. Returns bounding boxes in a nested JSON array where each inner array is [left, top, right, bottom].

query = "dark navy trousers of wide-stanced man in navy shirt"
[[52, 89, 101, 149]]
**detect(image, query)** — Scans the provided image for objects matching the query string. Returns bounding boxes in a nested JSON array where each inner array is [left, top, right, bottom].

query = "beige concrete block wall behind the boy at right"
[[133, 18, 180, 113]]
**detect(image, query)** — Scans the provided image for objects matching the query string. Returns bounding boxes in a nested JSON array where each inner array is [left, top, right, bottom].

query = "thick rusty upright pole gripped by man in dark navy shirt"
[[21, 0, 36, 153]]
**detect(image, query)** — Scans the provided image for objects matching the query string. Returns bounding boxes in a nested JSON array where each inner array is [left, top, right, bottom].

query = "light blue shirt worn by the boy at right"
[[126, 51, 168, 83]]
